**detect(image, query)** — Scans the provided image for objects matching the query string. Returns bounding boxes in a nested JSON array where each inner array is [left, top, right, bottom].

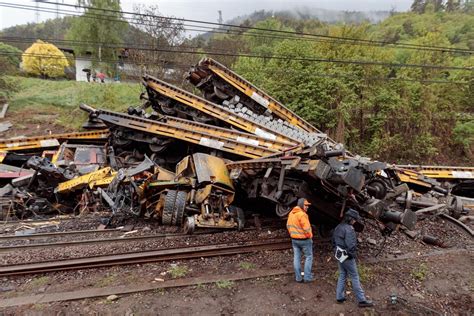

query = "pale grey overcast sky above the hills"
[[0, 0, 413, 29]]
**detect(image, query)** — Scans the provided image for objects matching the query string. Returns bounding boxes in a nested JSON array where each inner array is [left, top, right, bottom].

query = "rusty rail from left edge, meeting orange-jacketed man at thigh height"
[[0, 238, 291, 276]]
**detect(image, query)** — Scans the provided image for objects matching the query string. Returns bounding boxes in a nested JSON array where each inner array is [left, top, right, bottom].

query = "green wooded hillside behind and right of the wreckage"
[[202, 1, 474, 164]]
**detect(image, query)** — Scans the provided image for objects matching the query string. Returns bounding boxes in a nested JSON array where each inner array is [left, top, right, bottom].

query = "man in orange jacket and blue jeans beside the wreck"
[[286, 198, 313, 283]]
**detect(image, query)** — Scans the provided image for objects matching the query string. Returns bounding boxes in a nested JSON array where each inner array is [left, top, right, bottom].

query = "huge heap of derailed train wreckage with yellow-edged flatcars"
[[0, 58, 468, 233]]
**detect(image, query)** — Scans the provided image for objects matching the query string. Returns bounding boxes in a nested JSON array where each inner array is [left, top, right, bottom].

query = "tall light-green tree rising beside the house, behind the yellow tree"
[[67, 0, 127, 73]]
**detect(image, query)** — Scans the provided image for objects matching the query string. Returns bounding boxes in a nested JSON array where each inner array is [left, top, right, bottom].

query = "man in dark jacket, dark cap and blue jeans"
[[333, 208, 374, 307]]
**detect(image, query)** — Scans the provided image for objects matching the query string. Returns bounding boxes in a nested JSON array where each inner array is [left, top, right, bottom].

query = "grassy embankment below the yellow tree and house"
[[7, 76, 142, 134]]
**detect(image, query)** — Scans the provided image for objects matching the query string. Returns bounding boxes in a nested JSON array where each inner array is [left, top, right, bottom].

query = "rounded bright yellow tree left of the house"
[[22, 40, 69, 78]]
